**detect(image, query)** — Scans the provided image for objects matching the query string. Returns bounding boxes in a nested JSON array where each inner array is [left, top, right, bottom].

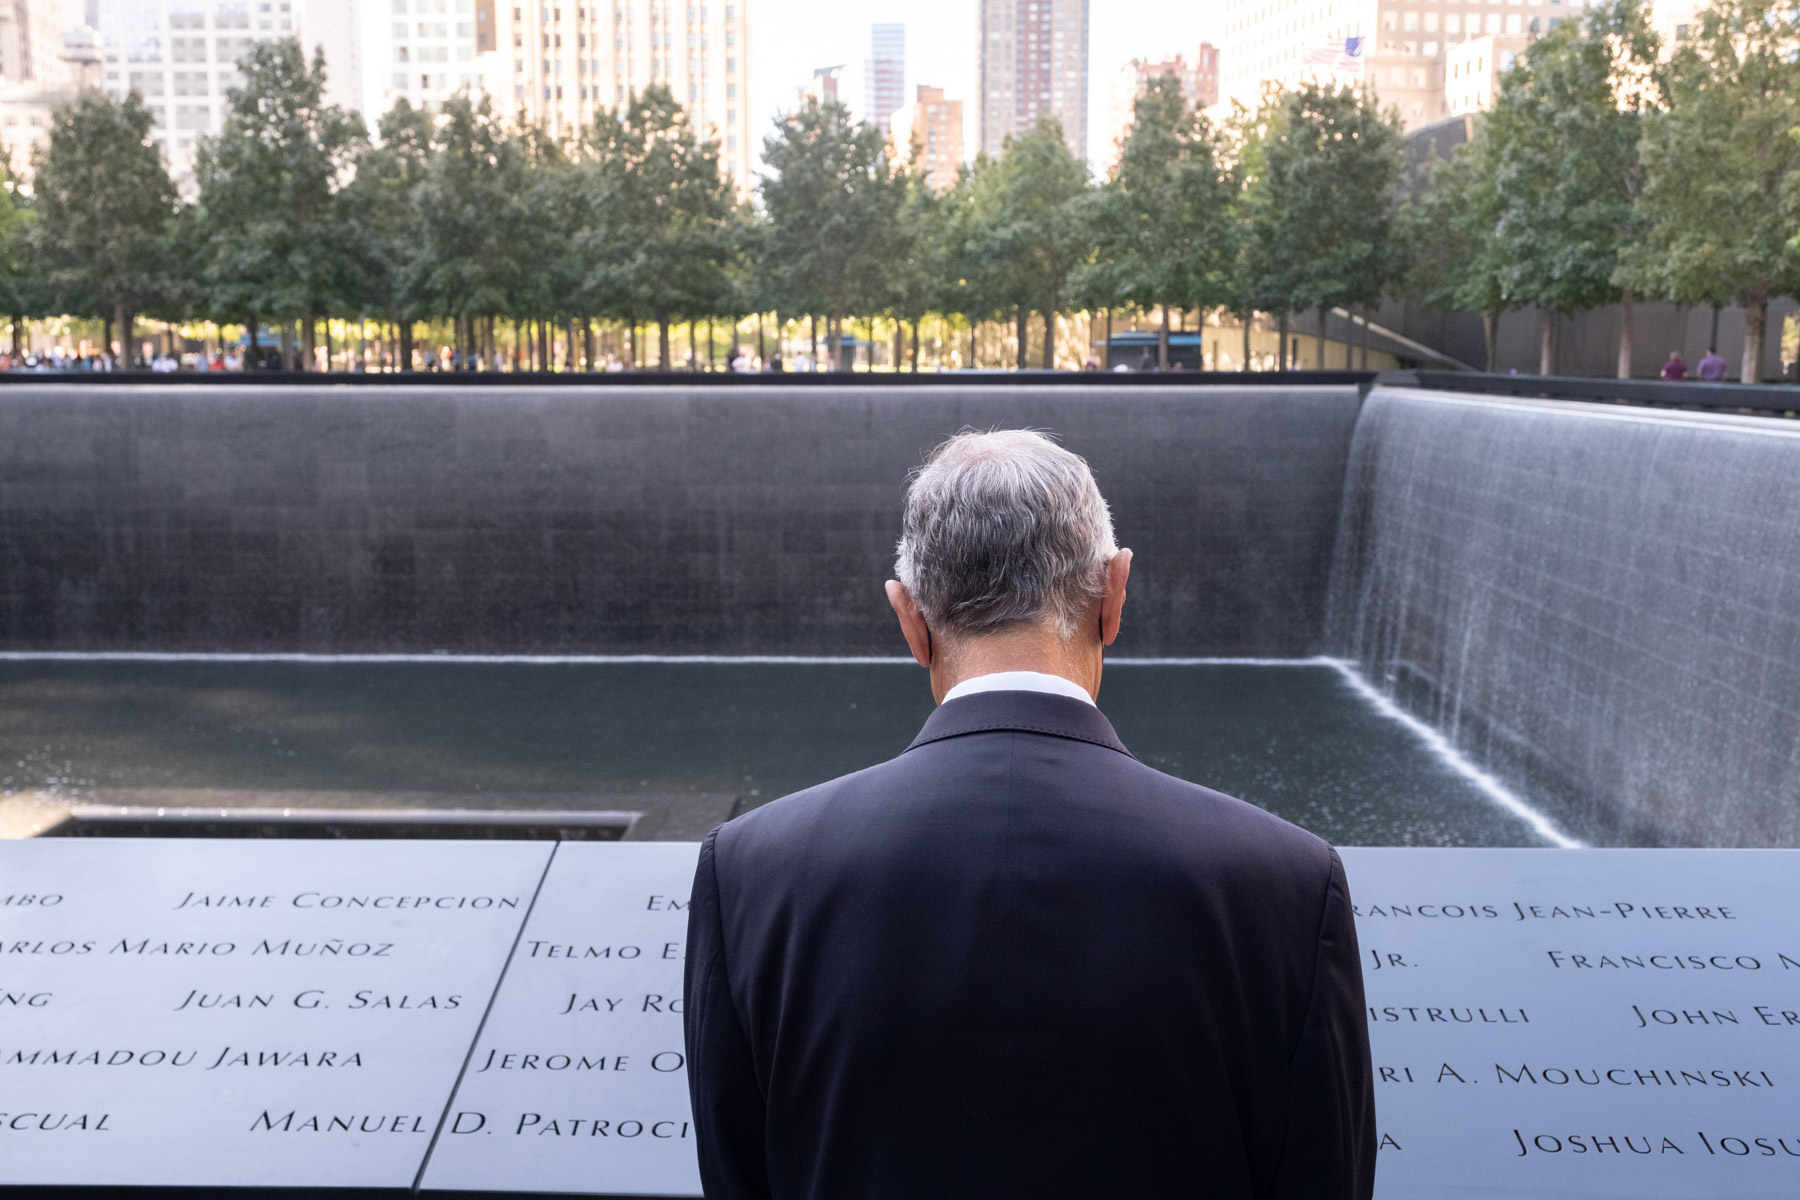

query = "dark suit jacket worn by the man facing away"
[[686, 691, 1375, 1200]]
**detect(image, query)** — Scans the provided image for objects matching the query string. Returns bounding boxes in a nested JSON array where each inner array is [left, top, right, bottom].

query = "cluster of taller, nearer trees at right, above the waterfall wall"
[[1413, 0, 1800, 381]]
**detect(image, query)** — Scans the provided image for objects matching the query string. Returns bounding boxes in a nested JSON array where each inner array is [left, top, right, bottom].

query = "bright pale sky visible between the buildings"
[[747, 0, 1224, 173]]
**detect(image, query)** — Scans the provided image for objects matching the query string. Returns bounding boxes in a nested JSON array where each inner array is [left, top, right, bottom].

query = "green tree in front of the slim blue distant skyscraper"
[[761, 97, 904, 371]]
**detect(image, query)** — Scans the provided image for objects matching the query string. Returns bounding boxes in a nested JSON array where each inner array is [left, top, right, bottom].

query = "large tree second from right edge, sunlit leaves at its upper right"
[[1487, 0, 1656, 374]]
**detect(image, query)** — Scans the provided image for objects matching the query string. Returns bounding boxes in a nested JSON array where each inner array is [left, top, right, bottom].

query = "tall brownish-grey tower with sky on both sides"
[[979, 0, 1087, 158]]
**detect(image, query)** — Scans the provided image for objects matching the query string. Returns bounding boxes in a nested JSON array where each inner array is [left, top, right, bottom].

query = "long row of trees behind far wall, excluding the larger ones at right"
[[0, 41, 1402, 367]]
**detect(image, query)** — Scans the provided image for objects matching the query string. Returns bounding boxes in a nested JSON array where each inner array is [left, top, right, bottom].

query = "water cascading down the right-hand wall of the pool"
[[1327, 389, 1800, 846]]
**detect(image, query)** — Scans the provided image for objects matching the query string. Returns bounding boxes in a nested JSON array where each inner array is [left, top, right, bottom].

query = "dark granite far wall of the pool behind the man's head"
[[0, 385, 1359, 655]]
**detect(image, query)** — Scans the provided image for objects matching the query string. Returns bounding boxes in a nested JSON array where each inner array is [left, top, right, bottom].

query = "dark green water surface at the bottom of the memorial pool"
[[0, 658, 1584, 846]]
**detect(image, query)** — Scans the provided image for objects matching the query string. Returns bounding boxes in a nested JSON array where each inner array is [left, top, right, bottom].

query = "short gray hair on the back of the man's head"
[[895, 430, 1118, 637]]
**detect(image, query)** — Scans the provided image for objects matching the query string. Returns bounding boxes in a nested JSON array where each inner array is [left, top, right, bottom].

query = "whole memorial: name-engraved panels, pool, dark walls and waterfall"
[[0, 376, 1800, 1198]]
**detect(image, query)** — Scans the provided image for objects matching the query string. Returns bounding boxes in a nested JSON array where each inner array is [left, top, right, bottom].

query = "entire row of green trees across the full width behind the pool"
[[0, 0, 1800, 380]]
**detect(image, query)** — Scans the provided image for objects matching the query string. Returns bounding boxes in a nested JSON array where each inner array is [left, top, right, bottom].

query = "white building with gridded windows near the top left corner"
[[90, 0, 301, 182]]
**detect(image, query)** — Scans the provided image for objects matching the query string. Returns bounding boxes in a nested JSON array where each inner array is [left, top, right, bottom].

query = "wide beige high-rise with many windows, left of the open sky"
[[507, 0, 761, 191]]
